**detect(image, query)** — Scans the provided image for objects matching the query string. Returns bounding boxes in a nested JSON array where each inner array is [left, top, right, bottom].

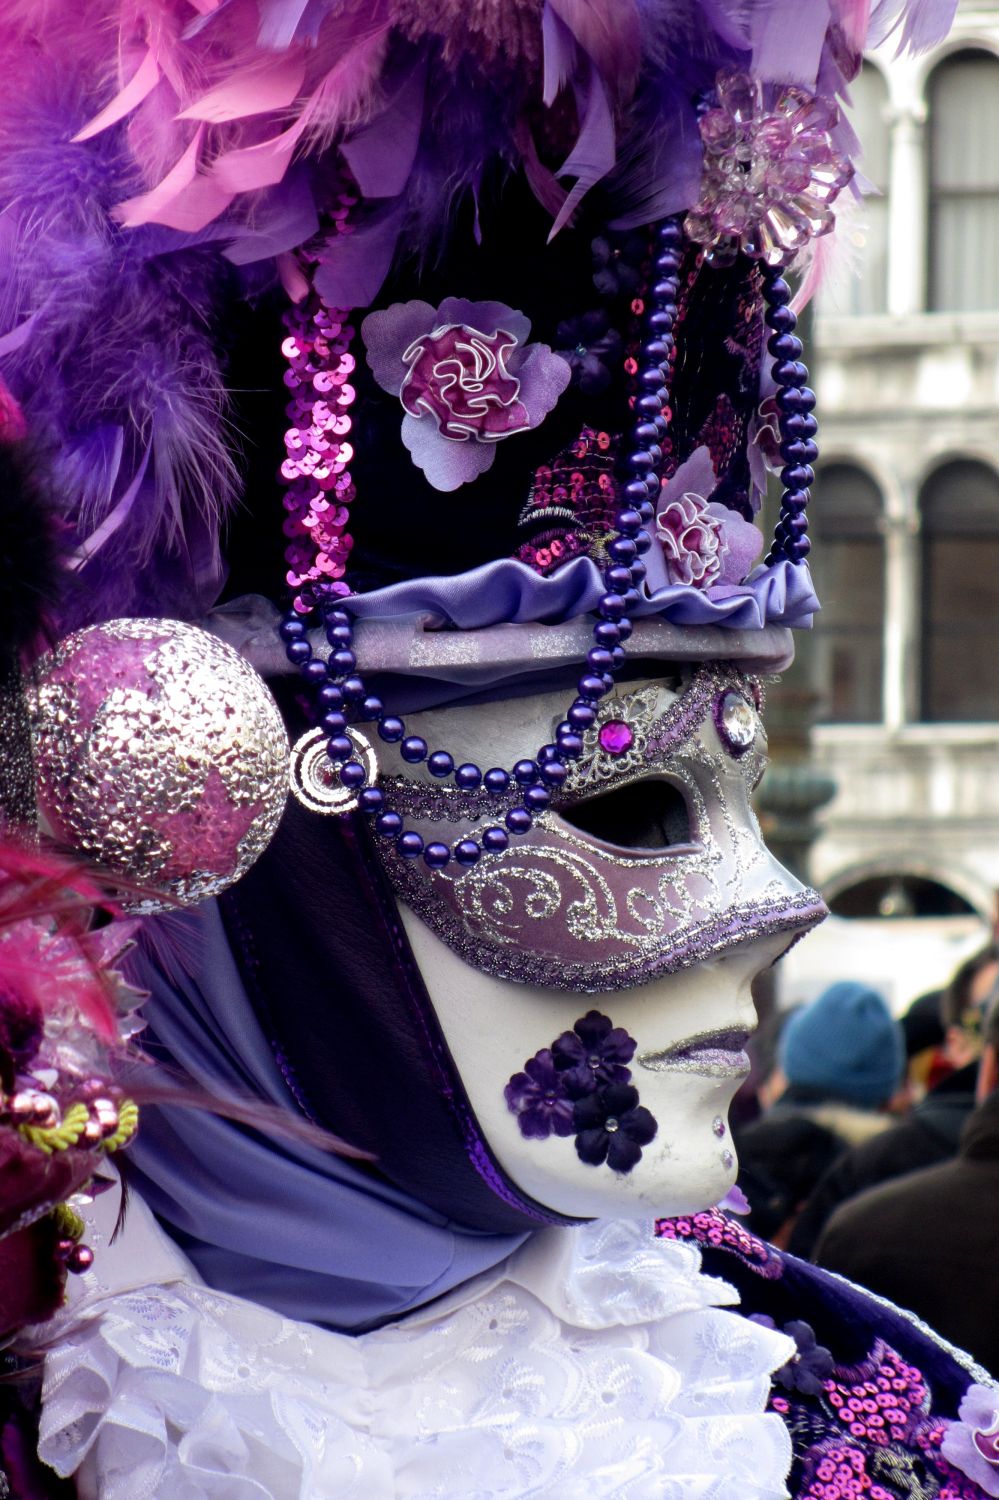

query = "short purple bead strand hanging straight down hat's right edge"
[[762, 267, 819, 567]]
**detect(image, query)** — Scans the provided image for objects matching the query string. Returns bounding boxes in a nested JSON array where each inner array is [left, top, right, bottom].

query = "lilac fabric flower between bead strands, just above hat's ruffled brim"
[[647, 447, 764, 590]]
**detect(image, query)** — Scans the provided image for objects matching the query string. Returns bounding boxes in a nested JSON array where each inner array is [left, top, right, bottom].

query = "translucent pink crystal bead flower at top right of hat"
[[684, 69, 854, 266]]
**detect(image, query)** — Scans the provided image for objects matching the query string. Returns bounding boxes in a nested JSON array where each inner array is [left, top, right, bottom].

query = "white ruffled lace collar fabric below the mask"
[[39, 1223, 794, 1500]]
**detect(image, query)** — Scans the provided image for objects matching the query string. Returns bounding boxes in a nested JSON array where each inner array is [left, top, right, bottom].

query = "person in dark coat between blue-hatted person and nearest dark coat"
[[788, 944, 999, 1260]]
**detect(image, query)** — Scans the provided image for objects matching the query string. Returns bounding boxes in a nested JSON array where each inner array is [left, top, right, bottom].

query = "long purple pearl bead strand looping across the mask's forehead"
[[279, 216, 684, 870]]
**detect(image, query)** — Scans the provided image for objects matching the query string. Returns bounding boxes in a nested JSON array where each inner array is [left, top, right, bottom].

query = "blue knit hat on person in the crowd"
[[780, 980, 905, 1109]]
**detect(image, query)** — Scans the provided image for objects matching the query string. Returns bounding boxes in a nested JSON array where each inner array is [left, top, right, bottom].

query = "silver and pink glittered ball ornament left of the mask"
[[33, 620, 288, 912]]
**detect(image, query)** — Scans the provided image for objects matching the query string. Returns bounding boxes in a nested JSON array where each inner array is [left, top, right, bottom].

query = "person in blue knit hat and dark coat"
[[737, 980, 905, 1248]]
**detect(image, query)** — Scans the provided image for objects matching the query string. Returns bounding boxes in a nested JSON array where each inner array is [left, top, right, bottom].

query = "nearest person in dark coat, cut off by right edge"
[[815, 1002, 999, 1373]]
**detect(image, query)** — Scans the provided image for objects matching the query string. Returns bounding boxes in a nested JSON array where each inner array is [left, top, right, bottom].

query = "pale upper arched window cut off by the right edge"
[[929, 53, 999, 312]]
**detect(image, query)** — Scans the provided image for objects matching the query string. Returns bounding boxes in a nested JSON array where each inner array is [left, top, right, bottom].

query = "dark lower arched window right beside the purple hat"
[[809, 464, 885, 725]]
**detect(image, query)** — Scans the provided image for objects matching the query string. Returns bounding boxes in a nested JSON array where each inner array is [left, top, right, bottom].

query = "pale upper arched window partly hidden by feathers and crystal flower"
[[824, 63, 890, 314]]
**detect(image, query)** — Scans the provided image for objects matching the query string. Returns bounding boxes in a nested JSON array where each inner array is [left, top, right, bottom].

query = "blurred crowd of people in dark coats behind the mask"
[[732, 944, 999, 1374]]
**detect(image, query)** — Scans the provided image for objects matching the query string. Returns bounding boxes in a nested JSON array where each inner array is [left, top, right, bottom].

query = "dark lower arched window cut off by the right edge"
[[920, 459, 999, 723]]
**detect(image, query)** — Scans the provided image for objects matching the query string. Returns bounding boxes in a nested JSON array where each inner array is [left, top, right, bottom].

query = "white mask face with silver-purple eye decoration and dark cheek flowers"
[[378, 669, 825, 1218]]
